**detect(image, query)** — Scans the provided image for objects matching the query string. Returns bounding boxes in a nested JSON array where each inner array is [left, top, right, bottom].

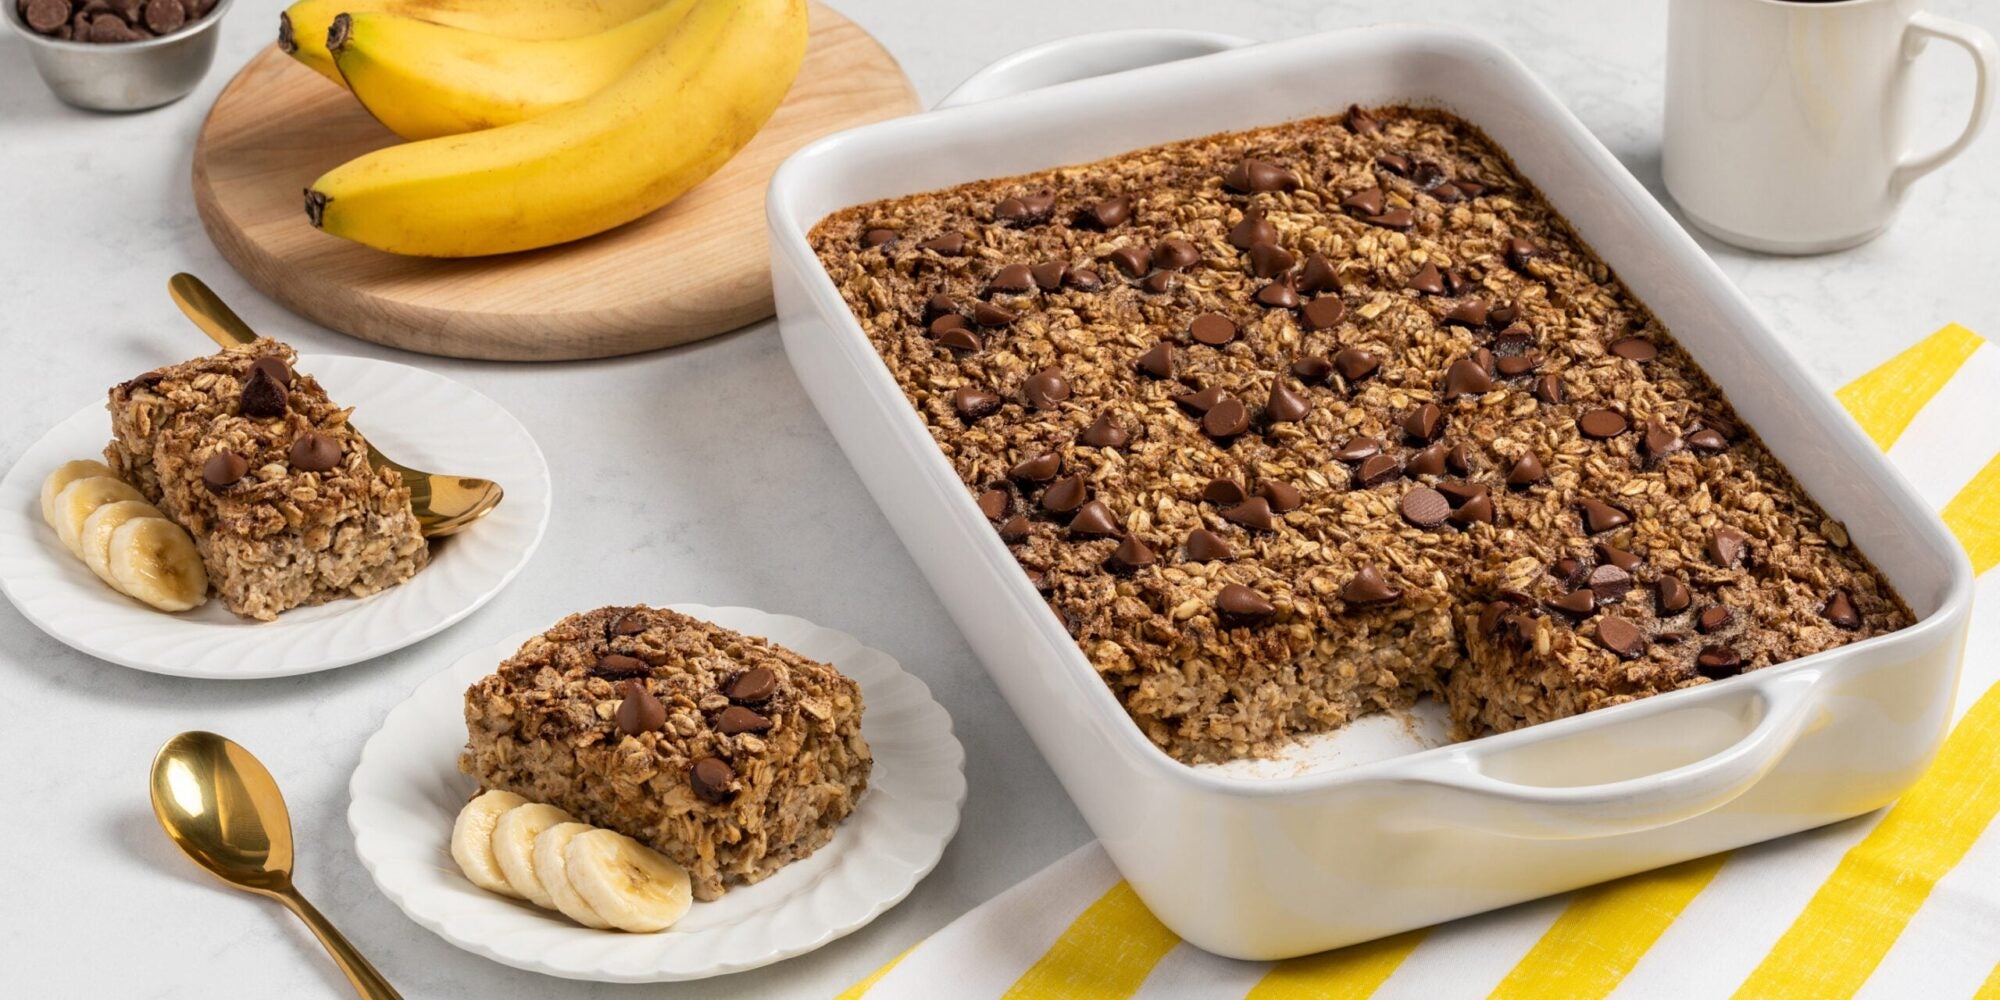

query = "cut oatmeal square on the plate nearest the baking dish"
[[458, 606, 872, 900]]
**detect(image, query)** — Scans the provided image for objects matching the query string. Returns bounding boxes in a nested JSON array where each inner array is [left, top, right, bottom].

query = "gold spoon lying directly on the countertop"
[[152, 732, 402, 1000]]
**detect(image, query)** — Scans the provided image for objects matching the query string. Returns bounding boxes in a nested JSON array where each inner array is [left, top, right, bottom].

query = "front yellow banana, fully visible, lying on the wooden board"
[[306, 0, 806, 256]]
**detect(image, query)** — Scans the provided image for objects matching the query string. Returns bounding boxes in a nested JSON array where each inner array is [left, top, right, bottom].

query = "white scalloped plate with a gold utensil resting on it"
[[0, 354, 550, 680]]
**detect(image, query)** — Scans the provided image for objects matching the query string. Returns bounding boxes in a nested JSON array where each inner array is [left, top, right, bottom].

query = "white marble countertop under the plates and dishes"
[[0, 0, 2000, 1000]]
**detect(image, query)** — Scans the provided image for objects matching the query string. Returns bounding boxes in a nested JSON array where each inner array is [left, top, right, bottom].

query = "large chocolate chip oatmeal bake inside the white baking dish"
[[812, 108, 1912, 762]]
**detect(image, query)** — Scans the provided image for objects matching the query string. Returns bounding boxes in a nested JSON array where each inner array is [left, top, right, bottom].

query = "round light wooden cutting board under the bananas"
[[194, 4, 918, 360]]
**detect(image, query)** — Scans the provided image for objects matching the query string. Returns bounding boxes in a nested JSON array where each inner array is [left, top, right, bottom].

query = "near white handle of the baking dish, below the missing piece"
[[1410, 670, 1820, 840]]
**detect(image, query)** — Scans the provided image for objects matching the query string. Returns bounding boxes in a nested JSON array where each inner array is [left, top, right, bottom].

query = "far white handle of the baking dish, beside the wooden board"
[[938, 28, 1252, 108]]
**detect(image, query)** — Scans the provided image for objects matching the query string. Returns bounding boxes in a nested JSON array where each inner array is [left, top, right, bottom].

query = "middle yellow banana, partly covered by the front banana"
[[326, 0, 694, 138]]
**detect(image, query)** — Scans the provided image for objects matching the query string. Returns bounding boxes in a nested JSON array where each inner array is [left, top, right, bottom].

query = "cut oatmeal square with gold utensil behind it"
[[104, 338, 430, 620]]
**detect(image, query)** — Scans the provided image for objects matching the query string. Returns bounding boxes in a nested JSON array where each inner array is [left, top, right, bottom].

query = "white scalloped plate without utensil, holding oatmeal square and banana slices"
[[348, 604, 966, 982]]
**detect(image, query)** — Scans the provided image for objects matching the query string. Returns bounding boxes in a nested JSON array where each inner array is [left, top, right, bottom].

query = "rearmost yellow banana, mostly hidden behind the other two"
[[278, 0, 660, 86]]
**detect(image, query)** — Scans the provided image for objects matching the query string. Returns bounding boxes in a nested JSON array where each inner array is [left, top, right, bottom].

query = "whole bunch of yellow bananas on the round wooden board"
[[278, 0, 806, 256]]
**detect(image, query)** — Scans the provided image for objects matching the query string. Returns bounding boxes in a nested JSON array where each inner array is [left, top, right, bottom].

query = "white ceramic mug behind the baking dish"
[[1664, 0, 2000, 254]]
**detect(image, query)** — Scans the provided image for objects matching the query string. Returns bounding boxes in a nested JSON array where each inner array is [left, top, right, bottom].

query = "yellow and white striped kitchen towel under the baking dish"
[[840, 326, 2000, 1000]]
